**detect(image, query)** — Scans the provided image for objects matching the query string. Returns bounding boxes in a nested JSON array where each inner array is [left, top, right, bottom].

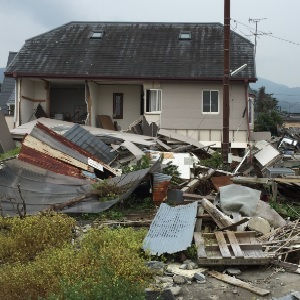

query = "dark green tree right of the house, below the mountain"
[[254, 86, 283, 135]]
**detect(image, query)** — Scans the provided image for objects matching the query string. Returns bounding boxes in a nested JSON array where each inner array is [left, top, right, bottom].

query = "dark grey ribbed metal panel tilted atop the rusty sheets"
[[63, 124, 117, 164]]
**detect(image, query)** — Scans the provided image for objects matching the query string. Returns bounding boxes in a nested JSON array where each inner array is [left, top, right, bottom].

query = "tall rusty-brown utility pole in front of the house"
[[222, 0, 230, 163]]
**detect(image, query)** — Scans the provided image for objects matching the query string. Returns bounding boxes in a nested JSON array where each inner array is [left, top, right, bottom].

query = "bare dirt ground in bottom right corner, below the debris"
[[179, 266, 300, 300]]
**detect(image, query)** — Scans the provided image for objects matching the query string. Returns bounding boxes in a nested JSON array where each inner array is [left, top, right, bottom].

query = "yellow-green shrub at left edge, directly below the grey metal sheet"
[[0, 213, 75, 263]]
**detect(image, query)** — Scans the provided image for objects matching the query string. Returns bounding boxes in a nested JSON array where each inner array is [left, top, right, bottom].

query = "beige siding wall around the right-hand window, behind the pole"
[[161, 83, 247, 148]]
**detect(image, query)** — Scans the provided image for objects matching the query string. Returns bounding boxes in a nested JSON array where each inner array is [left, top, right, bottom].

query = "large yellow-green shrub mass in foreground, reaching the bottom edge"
[[0, 228, 152, 300]]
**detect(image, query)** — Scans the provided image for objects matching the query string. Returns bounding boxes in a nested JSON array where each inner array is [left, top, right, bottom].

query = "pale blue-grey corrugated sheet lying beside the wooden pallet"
[[143, 201, 198, 255]]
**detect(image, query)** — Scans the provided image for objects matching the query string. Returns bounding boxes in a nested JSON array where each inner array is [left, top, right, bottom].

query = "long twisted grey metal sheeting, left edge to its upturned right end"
[[0, 160, 155, 215]]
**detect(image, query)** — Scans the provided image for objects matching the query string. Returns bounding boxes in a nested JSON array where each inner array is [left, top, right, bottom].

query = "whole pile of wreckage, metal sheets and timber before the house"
[[0, 118, 300, 296]]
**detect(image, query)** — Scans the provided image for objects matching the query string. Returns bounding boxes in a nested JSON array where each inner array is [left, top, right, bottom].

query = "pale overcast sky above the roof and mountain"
[[0, 0, 300, 87]]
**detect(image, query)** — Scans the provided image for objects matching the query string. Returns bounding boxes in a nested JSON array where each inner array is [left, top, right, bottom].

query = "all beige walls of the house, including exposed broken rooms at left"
[[15, 79, 248, 148]]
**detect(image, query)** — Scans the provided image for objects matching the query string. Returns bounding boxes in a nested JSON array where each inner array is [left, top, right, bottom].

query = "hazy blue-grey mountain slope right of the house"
[[250, 78, 300, 113]]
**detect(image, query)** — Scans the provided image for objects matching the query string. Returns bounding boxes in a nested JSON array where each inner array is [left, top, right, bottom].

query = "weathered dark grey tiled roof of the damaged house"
[[7, 22, 256, 80]]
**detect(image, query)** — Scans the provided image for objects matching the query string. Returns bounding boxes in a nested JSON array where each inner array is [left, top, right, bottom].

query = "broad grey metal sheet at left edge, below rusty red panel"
[[0, 160, 92, 215]]
